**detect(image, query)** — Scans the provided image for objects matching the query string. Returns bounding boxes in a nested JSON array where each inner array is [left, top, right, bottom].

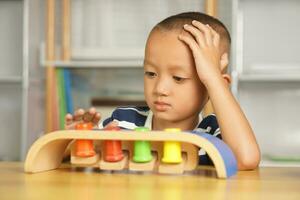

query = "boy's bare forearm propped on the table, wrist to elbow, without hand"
[[206, 77, 260, 170]]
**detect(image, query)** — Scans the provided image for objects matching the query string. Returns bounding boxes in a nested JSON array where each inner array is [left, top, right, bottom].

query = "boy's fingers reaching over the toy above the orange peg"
[[65, 108, 101, 130]]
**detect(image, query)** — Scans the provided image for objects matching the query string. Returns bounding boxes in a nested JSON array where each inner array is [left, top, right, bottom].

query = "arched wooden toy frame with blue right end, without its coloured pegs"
[[25, 130, 237, 178]]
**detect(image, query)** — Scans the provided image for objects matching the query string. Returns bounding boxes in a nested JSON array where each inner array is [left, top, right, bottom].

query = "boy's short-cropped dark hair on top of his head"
[[153, 12, 231, 49]]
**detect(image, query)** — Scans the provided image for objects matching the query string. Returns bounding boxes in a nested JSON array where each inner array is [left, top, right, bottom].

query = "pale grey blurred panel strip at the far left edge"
[[0, 1, 23, 161]]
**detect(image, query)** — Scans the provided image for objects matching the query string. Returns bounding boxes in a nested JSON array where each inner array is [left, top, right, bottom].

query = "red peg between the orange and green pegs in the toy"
[[103, 127, 124, 162]]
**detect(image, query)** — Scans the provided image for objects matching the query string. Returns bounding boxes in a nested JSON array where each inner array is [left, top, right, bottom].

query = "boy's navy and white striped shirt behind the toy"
[[99, 106, 222, 165]]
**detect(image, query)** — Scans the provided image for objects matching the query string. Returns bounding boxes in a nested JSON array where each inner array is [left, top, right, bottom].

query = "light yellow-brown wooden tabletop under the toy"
[[0, 162, 300, 200]]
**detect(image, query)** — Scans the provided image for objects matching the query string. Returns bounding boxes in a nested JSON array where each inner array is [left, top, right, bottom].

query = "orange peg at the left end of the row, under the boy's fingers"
[[75, 122, 96, 157]]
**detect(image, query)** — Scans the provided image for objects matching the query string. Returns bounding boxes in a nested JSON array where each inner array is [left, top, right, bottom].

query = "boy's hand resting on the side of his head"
[[178, 20, 228, 84]]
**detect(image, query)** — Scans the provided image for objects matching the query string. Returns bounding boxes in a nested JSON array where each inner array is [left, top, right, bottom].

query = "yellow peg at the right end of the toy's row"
[[162, 128, 182, 164]]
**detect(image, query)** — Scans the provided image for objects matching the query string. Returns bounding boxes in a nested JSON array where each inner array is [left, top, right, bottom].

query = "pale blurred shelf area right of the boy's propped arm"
[[236, 0, 300, 159]]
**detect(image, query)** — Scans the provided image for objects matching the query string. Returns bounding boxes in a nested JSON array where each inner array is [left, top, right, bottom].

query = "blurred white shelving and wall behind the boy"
[[0, 0, 300, 166]]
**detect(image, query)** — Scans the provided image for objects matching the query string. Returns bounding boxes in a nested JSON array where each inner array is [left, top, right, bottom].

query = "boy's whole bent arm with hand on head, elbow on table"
[[179, 21, 260, 170]]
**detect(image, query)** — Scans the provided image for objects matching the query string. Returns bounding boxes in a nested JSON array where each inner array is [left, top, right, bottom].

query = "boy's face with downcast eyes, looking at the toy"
[[144, 30, 207, 122]]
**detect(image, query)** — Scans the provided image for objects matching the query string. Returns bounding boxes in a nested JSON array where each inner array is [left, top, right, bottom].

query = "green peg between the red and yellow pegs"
[[133, 127, 152, 163]]
